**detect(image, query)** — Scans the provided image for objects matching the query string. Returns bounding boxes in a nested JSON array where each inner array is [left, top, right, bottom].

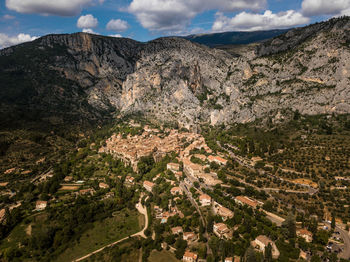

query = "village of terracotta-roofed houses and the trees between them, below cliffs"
[[0, 121, 350, 262]]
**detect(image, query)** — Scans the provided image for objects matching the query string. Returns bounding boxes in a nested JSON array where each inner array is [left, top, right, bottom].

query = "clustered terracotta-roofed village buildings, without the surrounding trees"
[[93, 126, 350, 262]]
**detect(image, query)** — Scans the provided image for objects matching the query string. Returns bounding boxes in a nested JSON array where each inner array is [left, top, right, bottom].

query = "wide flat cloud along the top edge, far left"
[[6, 0, 100, 16]]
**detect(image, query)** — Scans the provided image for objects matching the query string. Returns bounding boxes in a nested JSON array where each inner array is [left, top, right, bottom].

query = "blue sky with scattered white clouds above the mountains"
[[0, 0, 350, 48]]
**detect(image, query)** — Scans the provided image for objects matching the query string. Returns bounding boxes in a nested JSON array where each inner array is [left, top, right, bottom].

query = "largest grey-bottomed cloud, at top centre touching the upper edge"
[[127, 0, 266, 31]]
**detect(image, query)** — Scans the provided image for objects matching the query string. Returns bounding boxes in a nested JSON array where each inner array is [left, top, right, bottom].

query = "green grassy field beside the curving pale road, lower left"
[[56, 210, 143, 262]]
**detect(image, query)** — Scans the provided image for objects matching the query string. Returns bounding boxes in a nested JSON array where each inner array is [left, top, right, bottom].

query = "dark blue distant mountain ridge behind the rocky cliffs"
[[184, 29, 290, 47]]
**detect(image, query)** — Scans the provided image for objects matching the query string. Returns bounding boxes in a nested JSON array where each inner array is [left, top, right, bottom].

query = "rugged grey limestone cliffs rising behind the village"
[[0, 18, 350, 128]]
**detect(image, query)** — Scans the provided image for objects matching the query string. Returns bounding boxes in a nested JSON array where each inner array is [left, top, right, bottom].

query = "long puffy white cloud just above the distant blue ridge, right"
[[212, 10, 310, 32]]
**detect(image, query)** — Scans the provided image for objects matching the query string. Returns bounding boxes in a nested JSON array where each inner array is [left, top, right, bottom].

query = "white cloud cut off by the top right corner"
[[302, 0, 350, 16]]
